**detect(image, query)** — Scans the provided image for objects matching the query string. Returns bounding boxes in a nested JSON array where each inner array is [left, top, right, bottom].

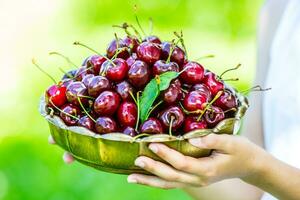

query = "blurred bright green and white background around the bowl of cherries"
[[0, 0, 262, 200]]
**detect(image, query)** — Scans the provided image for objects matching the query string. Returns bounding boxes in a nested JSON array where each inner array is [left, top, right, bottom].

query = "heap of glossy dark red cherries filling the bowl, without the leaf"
[[45, 32, 239, 136]]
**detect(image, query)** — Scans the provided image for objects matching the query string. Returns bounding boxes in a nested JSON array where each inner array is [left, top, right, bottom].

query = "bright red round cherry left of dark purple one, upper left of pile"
[[101, 58, 129, 82]]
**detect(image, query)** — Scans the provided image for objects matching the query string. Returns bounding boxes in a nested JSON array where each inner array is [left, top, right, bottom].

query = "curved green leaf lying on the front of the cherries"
[[139, 72, 178, 123]]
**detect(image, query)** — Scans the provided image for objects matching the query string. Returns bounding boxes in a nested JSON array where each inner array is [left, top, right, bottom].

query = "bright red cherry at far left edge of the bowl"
[[45, 85, 67, 107]]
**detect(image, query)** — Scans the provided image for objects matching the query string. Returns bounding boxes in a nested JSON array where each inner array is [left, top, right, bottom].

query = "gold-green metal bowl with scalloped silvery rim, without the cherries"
[[39, 94, 249, 174]]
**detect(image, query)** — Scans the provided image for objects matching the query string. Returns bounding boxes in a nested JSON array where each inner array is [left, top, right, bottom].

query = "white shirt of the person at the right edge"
[[262, 0, 300, 200]]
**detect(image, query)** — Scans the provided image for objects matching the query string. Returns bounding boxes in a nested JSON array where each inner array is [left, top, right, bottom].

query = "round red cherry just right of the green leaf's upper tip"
[[180, 62, 204, 84]]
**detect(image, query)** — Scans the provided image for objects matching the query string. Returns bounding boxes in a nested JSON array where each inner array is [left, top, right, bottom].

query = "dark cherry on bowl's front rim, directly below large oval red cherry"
[[95, 117, 117, 134]]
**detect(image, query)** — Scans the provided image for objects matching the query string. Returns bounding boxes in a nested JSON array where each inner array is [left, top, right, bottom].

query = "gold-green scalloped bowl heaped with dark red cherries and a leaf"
[[38, 24, 248, 174]]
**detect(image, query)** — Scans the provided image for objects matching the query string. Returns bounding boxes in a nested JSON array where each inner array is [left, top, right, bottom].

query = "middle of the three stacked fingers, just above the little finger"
[[135, 156, 200, 185]]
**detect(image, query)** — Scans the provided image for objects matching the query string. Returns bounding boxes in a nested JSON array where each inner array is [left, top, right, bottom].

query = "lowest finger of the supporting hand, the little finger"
[[127, 174, 184, 189]]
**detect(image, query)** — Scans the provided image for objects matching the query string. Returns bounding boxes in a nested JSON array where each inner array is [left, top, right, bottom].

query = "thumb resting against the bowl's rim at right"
[[189, 133, 236, 153]]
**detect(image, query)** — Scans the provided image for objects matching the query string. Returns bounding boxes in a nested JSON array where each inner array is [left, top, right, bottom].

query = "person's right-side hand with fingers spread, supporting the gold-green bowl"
[[128, 134, 267, 189]]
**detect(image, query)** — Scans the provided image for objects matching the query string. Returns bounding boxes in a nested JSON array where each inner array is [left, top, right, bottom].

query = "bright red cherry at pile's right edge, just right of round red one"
[[203, 72, 224, 95]]
